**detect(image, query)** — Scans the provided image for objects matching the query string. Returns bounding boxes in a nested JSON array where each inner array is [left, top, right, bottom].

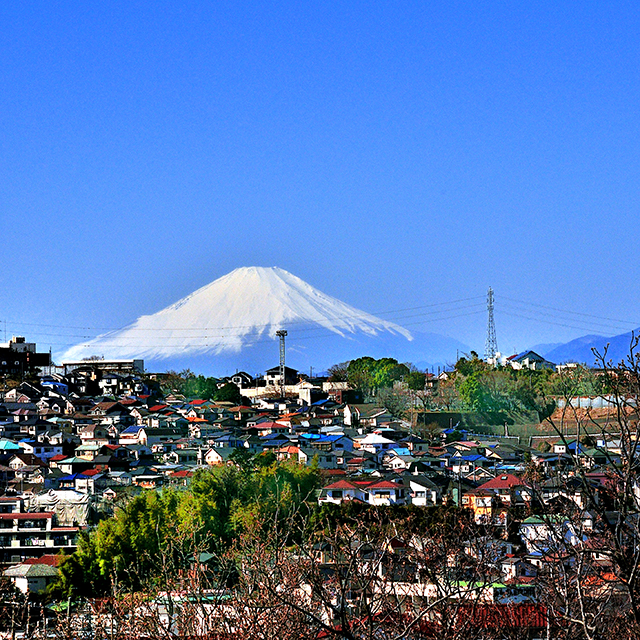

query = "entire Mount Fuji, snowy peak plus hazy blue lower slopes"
[[62, 267, 469, 375]]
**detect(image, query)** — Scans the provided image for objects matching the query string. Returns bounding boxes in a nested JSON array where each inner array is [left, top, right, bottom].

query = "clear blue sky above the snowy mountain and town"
[[0, 0, 640, 352]]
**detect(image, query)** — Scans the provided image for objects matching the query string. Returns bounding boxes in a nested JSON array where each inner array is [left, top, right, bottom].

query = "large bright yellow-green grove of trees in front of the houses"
[[51, 456, 320, 598]]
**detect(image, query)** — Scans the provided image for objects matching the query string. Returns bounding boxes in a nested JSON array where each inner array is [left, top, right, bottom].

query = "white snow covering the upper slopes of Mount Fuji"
[[62, 267, 413, 361]]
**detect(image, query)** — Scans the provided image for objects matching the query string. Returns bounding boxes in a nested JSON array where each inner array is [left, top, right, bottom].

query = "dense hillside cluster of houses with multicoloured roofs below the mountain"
[[0, 356, 632, 620]]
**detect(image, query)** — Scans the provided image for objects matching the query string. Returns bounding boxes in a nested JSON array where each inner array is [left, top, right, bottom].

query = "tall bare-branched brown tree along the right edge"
[[535, 337, 640, 640]]
